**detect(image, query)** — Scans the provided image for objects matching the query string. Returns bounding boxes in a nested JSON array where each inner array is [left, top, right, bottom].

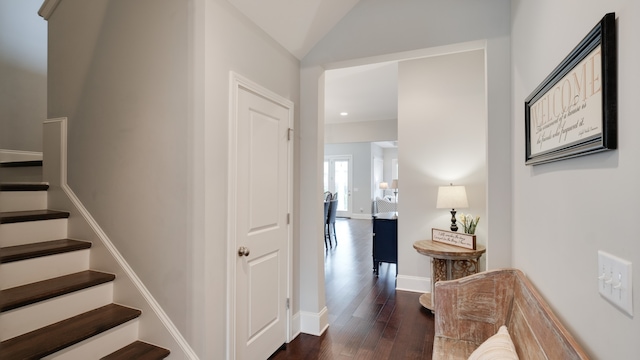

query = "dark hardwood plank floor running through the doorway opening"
[[271, 219, 434, 360]]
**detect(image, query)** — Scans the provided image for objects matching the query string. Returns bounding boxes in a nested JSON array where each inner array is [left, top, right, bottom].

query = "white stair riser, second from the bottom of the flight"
[[0, 282, 113, 341]]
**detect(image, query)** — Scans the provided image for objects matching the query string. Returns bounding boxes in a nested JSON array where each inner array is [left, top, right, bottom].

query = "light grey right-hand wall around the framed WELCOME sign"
[[512, 0, 640, 359]]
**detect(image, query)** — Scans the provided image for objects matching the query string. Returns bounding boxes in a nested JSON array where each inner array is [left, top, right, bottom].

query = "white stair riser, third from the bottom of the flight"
[[0, 249, 90, 290]]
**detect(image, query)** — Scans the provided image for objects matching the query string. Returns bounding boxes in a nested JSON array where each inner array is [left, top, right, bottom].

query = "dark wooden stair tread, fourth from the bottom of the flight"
[[0, 239, 91, 264]]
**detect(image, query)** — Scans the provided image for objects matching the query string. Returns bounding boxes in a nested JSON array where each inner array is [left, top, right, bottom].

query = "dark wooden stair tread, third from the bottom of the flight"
[[0, 270, 116, 312]]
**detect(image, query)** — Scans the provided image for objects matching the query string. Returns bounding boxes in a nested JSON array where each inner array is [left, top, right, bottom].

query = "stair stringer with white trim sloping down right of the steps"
[[43, 118, 199, 360]]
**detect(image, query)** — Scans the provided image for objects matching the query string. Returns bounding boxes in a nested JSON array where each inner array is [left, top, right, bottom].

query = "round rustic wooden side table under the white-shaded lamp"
[[413, 240, 487, 310]]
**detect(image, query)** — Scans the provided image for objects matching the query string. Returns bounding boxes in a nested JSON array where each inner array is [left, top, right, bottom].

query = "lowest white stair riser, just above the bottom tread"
[[42, 319, 138, 360]]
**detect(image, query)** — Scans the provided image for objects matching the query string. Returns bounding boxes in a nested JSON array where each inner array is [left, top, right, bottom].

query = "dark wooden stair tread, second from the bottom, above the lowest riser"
[[0, 304, 141, 359]]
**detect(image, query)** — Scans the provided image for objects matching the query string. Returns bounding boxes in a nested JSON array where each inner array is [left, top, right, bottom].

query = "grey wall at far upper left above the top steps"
[[0, 0, 47, 152]]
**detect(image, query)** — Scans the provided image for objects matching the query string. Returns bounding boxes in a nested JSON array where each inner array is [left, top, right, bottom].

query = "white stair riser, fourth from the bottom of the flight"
[[0, 219, 67, 247]]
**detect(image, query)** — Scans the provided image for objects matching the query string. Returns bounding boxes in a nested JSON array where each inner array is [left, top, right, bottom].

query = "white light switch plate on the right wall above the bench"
[[598, 250, 633, 316]]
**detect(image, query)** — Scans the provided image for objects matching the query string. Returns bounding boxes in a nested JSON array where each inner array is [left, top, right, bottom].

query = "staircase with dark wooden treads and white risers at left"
[[0, 162, 169, 360]]
